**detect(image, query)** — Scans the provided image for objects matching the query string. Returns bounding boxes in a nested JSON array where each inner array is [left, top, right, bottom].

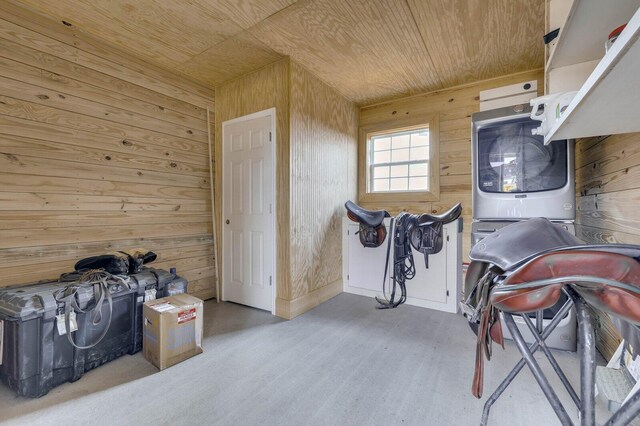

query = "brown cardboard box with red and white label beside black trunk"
[[142, 294, 203, 370]]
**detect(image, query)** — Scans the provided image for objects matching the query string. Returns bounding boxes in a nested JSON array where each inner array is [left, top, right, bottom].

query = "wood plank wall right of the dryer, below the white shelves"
[[575, 133, 640, 359]]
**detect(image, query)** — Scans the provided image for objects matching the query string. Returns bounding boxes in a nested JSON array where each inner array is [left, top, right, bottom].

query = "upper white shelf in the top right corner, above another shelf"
[[546, 0, 640, 71]]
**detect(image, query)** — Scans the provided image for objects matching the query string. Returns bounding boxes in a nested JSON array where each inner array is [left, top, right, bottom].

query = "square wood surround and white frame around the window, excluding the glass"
[[358, 114, 440, 205]]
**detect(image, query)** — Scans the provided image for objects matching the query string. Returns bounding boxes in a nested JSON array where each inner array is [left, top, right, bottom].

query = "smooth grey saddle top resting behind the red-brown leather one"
[[469, 217, 584, 271]]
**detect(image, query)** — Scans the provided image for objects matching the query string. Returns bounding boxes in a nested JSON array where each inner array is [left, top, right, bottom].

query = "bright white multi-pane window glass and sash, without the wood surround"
[[369, 128, 429, 192]]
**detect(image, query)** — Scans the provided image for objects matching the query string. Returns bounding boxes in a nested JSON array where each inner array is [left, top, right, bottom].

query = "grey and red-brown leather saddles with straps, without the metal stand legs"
[[461, 218, 640, 422]]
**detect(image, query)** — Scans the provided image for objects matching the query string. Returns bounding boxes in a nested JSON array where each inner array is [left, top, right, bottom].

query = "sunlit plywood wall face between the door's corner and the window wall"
[[290, 63, 358, 299]]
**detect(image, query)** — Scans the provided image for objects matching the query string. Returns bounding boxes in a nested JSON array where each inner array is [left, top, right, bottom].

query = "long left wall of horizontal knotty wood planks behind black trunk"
[[0, 1, 215, 298]]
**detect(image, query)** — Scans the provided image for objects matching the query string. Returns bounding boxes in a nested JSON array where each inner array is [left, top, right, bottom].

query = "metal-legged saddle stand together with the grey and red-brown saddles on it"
[[461, 219, 640, 426]]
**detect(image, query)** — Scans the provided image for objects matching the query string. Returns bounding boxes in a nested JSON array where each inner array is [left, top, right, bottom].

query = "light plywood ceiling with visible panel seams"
[[16, 0, 544, 104]]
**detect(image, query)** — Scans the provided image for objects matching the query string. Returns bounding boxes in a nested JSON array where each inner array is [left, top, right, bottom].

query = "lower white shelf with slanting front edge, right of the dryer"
[[545, 6, 640, 144]]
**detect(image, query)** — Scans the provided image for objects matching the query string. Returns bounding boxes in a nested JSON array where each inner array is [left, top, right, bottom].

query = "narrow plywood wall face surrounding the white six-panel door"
[[214, 59, 290, 308]]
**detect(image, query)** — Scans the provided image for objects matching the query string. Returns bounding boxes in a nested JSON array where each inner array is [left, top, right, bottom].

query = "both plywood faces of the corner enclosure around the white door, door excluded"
[[215, 58, 358, 318]]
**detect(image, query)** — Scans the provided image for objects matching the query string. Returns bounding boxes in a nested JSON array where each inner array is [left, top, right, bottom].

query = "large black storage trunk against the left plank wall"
[[0, 268, 187, 397]]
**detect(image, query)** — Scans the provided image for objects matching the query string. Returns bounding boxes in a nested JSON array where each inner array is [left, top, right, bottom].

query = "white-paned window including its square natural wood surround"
[[358, 112, 440, 208]]
